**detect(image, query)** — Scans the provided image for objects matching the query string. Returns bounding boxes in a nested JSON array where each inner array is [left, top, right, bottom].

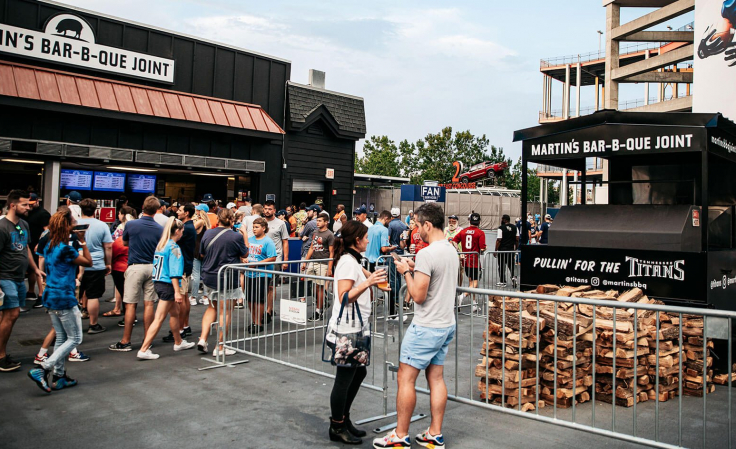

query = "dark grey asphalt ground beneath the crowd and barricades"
[[0, 274, 727, 449]]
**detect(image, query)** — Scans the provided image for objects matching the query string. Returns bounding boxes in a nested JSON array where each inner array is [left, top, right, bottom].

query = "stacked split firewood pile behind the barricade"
[[476, 285, 716, 411]]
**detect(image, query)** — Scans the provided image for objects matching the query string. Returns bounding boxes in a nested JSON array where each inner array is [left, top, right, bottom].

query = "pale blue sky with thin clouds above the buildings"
[[64, 0, 684, 160]]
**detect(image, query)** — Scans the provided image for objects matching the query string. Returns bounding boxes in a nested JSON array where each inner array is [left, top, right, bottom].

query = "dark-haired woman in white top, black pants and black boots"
[[330, 220, 388, 444]]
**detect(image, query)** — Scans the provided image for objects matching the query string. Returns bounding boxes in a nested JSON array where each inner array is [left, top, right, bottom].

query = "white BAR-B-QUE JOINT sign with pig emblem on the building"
[[0, 14, 174, 84]]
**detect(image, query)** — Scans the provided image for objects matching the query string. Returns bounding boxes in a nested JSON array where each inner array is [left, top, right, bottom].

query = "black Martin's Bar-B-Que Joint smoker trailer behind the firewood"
[[514, 110, 736, 310]]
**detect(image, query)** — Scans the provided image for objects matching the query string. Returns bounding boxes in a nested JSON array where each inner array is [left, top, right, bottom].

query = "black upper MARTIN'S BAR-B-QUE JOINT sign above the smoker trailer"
[[523, 124, 704, 161]]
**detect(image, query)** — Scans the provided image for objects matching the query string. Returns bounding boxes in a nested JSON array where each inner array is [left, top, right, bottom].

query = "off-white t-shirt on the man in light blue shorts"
[[414, 240, 460, 328]]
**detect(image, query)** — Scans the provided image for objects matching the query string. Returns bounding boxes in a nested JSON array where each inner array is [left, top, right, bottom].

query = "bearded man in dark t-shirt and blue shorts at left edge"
[[0, 190, 43, 372]]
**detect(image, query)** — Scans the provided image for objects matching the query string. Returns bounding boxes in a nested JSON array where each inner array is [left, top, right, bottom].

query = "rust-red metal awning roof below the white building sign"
[[0, 61, 285, 134]]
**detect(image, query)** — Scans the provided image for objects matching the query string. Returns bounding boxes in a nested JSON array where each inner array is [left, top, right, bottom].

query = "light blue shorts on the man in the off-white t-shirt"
[[399, 323, 455, 370]]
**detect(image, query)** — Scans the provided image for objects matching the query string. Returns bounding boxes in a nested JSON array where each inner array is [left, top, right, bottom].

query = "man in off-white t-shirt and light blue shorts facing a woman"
[[373, 203, 459, 448]]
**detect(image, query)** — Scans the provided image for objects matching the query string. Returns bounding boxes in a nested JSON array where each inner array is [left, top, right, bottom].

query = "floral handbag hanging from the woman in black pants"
[[322, 292, 371, 368]]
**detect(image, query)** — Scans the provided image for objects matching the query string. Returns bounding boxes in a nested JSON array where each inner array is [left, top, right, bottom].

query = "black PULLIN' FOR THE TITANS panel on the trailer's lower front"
[[521, 245, 704, 302]]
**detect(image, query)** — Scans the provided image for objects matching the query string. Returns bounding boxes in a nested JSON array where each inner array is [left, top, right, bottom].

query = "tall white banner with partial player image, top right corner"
[[693, 0, 736, 120]]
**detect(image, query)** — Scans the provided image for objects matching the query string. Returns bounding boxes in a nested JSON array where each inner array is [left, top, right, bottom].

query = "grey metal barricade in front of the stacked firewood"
[[432, 287, 736, 448]]
